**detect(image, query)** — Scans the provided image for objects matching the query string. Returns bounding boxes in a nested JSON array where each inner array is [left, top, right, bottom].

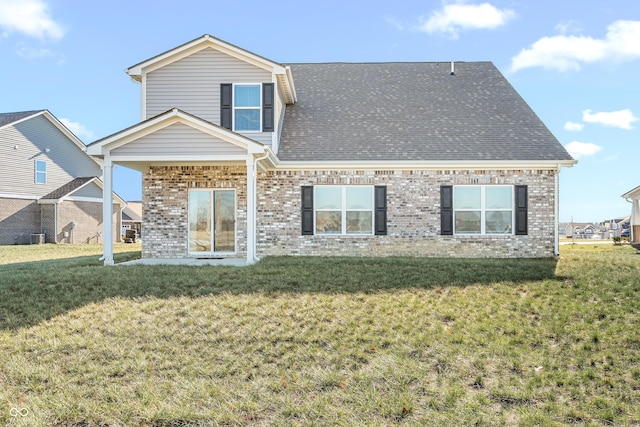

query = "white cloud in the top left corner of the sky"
[[0, 0, 64, 41]]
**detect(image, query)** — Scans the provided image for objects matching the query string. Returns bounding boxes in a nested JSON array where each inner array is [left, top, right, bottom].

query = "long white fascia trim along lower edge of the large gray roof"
[[275, 160, 576, 170]]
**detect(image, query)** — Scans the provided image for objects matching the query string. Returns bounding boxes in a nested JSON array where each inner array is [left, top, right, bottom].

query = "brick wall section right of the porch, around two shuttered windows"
[[257, 170, 555, 258]]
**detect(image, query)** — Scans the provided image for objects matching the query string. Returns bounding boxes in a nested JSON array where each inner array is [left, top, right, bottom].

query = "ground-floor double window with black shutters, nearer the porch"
[[314, 186, 373, 235]]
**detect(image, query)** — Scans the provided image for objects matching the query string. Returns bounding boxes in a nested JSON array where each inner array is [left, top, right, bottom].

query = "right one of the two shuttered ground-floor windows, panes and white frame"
[[453, 185, 513, 234]]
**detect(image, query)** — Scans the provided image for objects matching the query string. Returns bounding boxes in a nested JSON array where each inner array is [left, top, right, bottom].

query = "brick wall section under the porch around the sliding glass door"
[[142, 166, 247, 258]]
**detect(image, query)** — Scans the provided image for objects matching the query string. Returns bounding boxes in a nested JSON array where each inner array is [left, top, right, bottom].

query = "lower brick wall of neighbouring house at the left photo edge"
[[0, 198, 42, 245]]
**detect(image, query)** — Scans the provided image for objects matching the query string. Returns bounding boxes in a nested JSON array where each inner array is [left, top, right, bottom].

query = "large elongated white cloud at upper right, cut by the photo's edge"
[[510, 21, 640, 72]]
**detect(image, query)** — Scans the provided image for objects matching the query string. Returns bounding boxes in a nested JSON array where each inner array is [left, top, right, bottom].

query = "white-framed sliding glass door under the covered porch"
[[189, 190, 236, 254]]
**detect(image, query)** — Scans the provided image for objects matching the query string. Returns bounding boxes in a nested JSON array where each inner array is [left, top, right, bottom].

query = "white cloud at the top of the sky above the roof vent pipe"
[[420, 3, 515, 38]]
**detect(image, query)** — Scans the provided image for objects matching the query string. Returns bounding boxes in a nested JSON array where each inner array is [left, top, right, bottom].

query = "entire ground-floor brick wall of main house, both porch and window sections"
[[142, 166, 555, 258]]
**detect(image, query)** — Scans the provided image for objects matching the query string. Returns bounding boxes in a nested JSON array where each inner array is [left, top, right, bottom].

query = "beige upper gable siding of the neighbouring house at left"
[[0, 116, 101, 196]]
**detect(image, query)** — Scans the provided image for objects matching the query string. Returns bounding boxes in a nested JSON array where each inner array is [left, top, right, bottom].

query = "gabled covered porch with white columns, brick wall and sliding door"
[[87, 109, 275, 265]]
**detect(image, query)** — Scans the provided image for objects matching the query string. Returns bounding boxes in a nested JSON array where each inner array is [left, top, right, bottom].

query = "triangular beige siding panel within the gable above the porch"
[[111, 123, 247, 156]]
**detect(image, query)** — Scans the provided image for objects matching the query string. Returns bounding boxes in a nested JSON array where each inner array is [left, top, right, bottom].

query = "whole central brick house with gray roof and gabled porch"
[[88, 35, 575, 264]]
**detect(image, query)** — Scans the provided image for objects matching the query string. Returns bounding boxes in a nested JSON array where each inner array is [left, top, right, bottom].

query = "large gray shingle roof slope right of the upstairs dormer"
[[278, 62, 571, 161]]
